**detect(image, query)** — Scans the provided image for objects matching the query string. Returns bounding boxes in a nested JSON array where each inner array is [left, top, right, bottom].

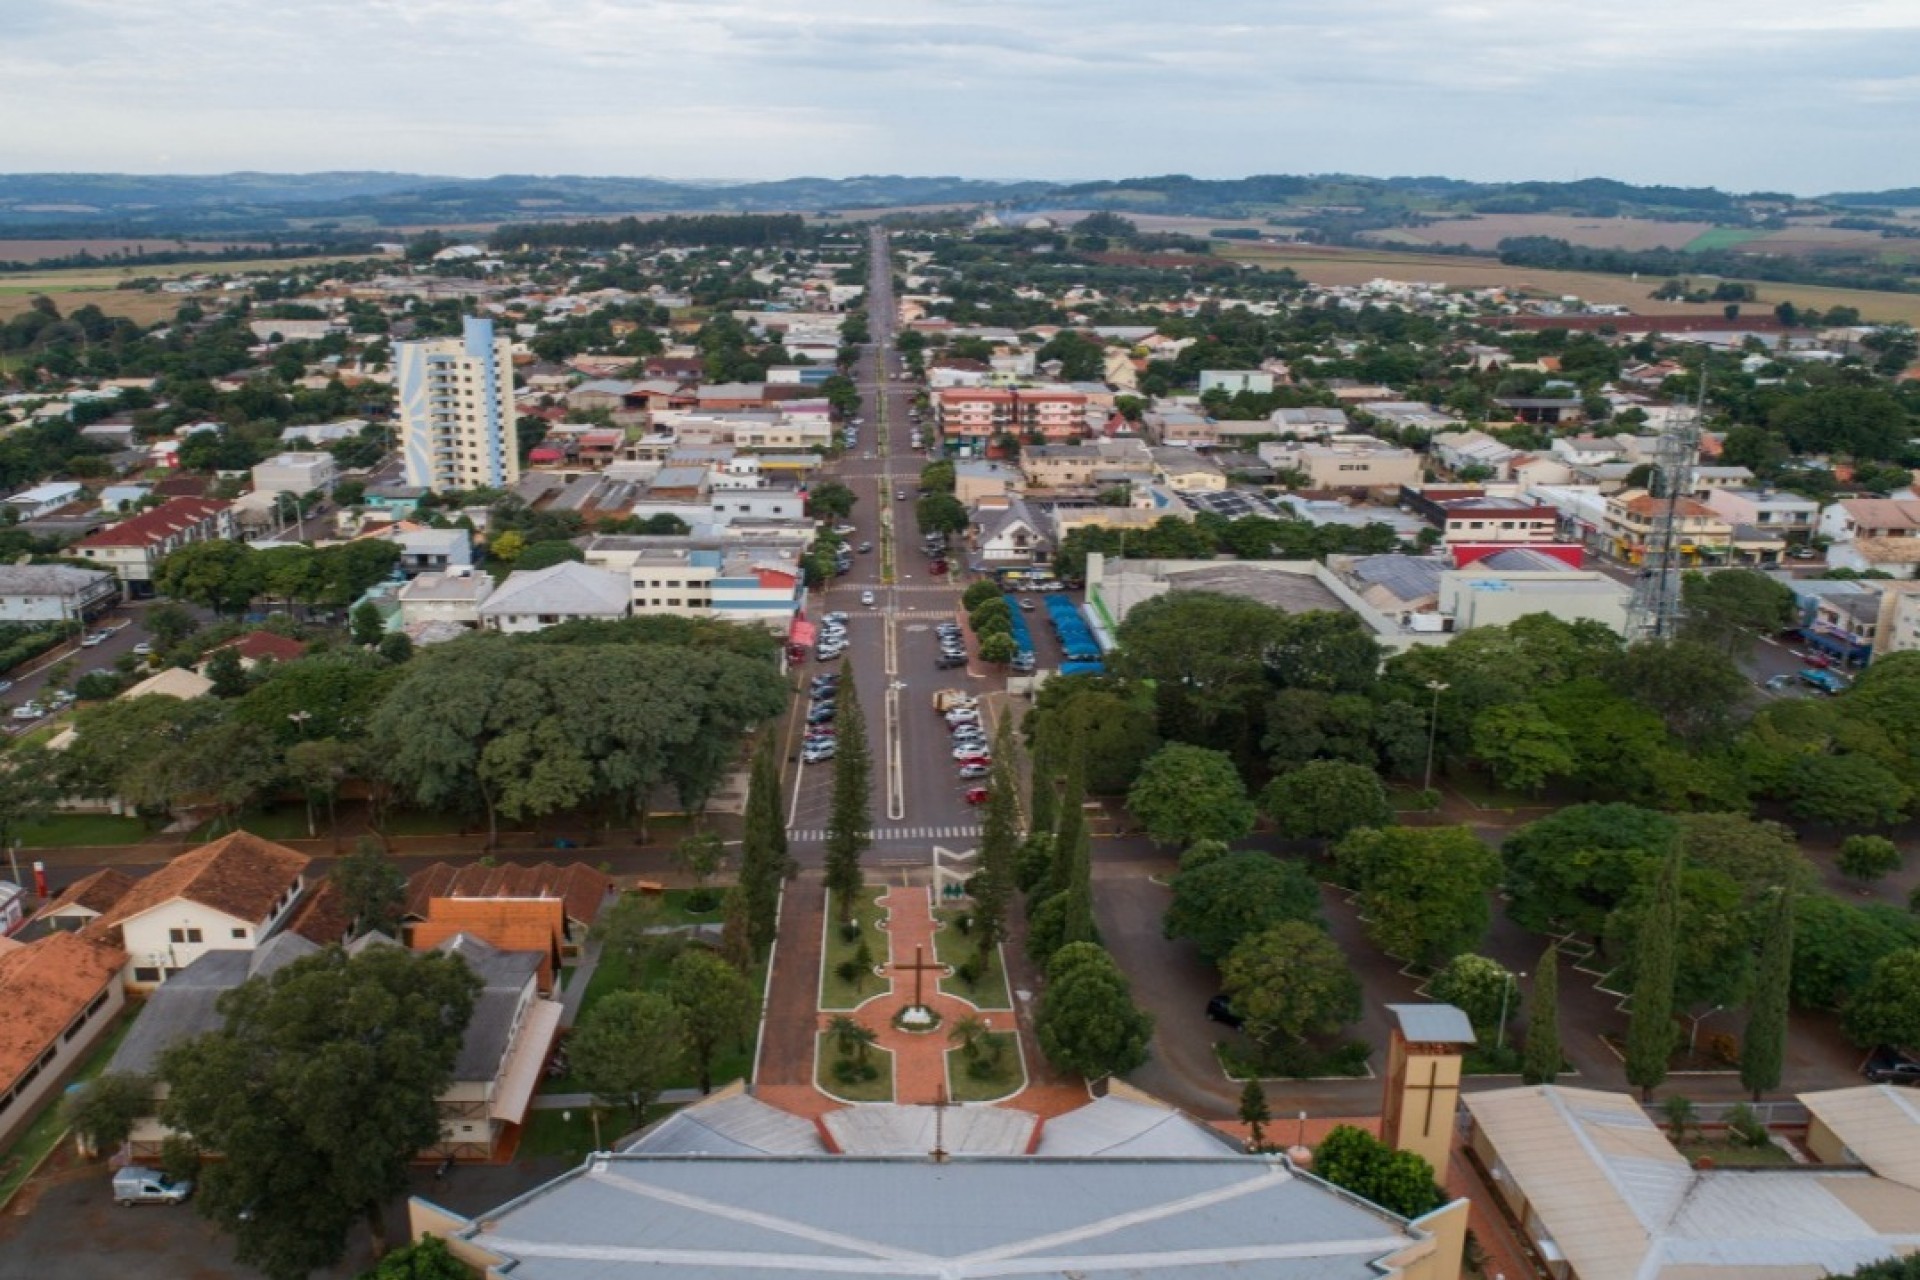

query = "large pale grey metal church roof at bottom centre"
[[457, 1155, 1421, 1280]]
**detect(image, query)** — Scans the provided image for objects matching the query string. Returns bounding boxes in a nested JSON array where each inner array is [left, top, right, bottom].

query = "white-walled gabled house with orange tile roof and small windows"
[[81, 831, 311, 990]]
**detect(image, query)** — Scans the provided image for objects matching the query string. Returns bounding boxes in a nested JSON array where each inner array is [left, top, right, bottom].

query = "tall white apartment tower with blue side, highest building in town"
[[394, 317, 520, 493]]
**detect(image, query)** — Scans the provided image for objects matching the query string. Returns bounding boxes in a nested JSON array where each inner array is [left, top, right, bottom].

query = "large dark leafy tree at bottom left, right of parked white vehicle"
[[159, 946, 480, 1280]]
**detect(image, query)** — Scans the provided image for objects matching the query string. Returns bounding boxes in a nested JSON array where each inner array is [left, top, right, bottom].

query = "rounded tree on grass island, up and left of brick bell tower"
[[1221, 919, 1359, 1040]]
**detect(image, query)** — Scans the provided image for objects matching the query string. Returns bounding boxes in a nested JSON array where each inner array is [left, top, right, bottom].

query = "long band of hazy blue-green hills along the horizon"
[[0, 173, 1889, 240]]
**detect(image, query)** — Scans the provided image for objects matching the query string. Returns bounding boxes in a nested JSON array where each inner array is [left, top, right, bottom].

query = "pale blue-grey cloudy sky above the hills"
[[0, 0, 1920, 194]]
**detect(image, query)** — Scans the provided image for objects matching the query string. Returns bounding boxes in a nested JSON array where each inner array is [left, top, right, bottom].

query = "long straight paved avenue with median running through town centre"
[[787, 228, 1004, 865]]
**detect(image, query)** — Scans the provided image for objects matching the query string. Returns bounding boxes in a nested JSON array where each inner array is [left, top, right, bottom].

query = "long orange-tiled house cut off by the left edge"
[[0, 933, 127, 1148]]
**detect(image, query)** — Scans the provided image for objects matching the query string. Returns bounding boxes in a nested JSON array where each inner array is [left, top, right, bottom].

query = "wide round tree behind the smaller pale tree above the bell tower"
[[1334, 827, 1500, 965]]
